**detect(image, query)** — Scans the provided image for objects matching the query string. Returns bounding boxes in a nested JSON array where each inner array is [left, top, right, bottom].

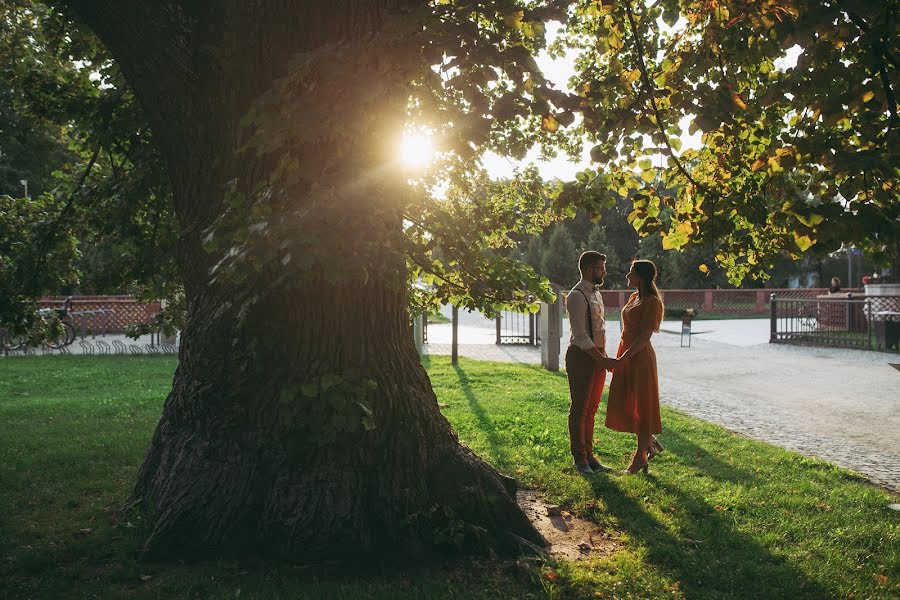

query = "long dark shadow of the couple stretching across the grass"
[[593, 476, 833, 600]]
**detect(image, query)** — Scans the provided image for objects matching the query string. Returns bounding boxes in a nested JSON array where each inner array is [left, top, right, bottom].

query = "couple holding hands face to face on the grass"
[[566, 250, 663, 475]]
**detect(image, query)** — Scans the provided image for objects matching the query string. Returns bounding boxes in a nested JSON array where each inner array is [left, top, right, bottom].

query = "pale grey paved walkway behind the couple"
[[426, 313, 900, 492]]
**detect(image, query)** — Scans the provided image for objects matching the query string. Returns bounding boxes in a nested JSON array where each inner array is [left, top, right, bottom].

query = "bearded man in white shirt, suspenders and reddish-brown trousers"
[[566, 250, 617, 475]]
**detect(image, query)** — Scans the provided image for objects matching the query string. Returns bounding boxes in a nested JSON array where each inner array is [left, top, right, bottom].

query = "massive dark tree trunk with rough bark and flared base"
[[67, 0, 543, 559]]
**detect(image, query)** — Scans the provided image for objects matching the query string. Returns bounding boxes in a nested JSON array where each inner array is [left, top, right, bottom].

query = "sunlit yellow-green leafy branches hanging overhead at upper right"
[[413, 0, 900, 283]]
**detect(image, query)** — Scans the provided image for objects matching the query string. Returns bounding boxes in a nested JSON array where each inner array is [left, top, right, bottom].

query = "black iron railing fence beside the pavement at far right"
[[769, 294, 900, 352]]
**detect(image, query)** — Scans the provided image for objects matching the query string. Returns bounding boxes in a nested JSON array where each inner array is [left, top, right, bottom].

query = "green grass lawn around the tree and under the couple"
[[0, 357, 900, 599]]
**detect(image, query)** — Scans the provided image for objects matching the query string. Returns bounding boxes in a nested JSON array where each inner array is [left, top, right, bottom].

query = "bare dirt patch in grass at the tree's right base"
[[516, 490, 621, 560]]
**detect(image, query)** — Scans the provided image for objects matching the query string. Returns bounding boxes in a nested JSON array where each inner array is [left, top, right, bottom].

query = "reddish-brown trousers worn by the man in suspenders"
[[566, 345, 606, 464]]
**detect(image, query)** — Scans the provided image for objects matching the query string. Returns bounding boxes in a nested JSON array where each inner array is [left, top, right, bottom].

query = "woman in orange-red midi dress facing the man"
[[606, 260, 663, 474]]
